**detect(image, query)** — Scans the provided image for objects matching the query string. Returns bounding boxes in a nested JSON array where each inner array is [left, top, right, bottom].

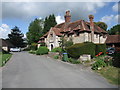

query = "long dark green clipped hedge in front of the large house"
[[66, 42, 106, 58]]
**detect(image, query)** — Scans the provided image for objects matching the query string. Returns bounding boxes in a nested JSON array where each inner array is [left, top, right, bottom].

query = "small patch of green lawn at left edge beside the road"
[[0, 52, 12, 67]]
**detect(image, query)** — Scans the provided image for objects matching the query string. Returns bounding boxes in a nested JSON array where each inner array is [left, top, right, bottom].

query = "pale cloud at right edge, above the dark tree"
[[100, 15, 120, 28]]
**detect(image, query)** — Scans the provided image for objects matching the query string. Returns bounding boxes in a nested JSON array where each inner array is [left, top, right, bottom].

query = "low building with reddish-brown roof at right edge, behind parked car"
[[105, 35, 120, 52]]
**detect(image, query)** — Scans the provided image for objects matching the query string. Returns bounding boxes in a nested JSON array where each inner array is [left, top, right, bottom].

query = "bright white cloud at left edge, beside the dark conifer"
[[0, 24, 11, 39]]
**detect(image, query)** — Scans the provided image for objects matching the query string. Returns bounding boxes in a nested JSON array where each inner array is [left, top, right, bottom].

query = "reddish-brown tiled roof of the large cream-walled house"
[[42, 20, 107, 38]]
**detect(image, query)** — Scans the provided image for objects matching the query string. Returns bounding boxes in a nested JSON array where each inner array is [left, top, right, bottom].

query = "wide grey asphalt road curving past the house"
[[2, 52, 116, 88]]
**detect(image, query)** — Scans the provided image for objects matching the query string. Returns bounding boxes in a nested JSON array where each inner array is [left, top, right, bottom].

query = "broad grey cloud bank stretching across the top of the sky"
[[2, 0, 106, 20]]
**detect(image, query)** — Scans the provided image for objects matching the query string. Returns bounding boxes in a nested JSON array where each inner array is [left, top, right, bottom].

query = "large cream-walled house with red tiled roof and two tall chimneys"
[[38, 11, 107, 50]]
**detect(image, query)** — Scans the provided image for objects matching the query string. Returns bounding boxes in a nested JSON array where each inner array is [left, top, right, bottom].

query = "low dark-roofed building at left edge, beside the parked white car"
[[0, 39, 13, 51]]
